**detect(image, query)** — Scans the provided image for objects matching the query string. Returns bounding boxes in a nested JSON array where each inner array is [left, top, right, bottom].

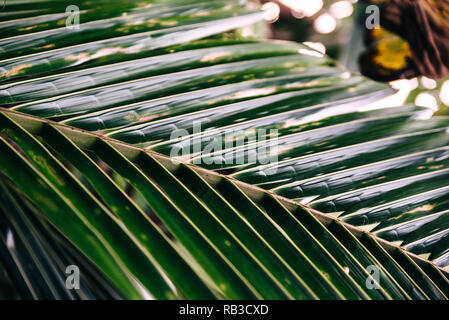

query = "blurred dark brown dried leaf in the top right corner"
[[380, 0, 449, 79]]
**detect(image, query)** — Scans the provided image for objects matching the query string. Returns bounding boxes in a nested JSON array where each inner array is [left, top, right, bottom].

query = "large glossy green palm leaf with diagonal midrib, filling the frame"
[[0, 0, 449, 299]]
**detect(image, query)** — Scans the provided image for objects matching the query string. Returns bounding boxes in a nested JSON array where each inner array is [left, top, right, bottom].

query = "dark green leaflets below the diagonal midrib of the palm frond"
[[2, 110, 446, 299]]
